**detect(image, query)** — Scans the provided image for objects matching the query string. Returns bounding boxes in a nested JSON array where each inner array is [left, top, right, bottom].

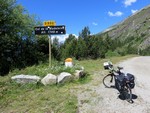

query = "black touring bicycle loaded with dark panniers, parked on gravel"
[[103, 62, 135, 103]]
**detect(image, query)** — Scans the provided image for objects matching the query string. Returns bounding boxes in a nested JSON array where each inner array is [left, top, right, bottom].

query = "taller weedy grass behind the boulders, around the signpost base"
[[9, 63, 81, 77]]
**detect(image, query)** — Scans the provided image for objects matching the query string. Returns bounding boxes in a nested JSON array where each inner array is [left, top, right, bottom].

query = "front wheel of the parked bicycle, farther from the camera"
[[103, 74, 115, 88]]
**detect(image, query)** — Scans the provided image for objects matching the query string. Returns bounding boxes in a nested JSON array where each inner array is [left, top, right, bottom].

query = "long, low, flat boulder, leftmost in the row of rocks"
[[11, 74, 41, 83]]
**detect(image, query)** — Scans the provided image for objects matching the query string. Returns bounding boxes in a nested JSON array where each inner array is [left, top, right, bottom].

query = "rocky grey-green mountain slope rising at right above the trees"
[[98, 6, 150, 49]]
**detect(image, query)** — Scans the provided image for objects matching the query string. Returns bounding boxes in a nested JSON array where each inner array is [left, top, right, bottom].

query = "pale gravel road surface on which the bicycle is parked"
[[78, 57, 150, 113]]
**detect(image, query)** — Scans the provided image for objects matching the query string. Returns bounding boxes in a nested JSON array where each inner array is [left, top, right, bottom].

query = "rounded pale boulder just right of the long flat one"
[[41, 74, 57, 85]]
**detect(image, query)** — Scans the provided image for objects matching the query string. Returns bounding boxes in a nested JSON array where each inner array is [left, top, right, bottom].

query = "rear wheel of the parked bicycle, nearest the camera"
[[124, 84, 133, 103]]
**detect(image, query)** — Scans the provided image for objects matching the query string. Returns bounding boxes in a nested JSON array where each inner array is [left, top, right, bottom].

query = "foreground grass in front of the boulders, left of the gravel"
[[0, 82, 77, 113]]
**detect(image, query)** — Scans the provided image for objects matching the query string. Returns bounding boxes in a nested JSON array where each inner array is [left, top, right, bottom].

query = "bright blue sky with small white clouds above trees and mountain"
[[17, 0, 150, 41]]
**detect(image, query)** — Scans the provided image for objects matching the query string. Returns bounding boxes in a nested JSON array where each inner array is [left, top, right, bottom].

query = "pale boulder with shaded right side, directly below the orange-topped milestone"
[[57, 72, 73, 83]]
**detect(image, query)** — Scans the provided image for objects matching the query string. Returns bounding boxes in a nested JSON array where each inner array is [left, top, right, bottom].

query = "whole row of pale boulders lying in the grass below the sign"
[[11, 70, 85, 85]]
